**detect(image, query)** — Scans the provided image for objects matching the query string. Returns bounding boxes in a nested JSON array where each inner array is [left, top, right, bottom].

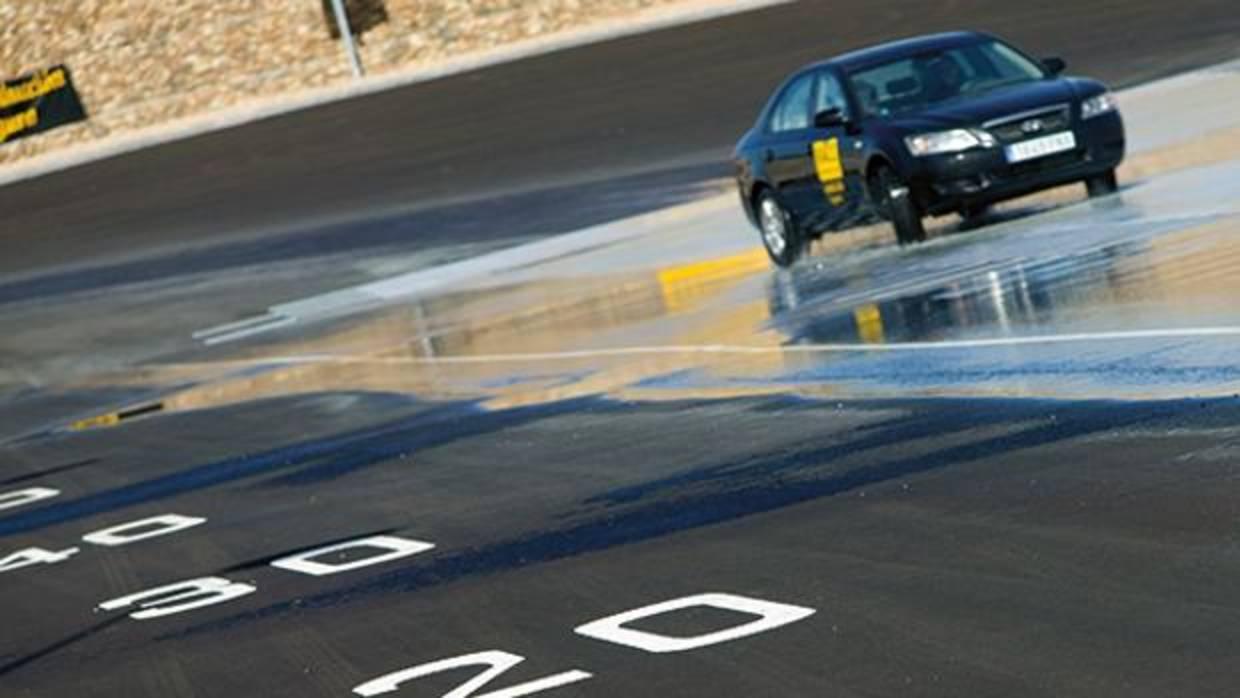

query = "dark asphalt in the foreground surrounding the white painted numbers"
[[0, 394, 1240, 698]]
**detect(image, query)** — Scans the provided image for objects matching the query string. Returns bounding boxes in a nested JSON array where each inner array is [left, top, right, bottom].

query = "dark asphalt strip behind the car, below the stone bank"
[[0, 0, 1240, 286]]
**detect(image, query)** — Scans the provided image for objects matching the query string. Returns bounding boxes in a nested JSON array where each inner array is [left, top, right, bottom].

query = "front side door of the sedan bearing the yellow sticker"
[[810, 69, 866, 228]]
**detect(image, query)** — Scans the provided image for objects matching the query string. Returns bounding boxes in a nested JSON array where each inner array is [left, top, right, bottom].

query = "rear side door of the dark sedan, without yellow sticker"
[[761, 73, 822, 221]]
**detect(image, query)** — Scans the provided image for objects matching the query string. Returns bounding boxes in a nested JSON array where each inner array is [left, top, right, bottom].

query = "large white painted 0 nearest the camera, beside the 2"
[[575, 594, 815, 653]]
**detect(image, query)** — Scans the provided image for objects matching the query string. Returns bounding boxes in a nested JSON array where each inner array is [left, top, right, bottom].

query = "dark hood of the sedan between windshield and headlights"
[[890, 79, 1083, 131]]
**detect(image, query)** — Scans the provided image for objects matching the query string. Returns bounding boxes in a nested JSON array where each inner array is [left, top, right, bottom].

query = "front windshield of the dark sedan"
[[849, 41, 1045, 117]]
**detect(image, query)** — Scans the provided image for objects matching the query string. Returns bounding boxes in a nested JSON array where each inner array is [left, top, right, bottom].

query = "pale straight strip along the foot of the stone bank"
[[0, 0, 792, 186]]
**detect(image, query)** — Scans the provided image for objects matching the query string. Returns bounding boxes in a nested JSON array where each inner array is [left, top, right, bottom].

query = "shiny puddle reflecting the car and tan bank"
[[62, 181, 1240, 431]]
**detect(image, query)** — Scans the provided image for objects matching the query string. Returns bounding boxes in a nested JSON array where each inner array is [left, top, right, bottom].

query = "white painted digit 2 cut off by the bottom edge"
[[353, 650, 593, 698]]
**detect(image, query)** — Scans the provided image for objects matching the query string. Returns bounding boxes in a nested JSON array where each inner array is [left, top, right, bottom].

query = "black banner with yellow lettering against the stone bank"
[[0, 66, 86, 144]]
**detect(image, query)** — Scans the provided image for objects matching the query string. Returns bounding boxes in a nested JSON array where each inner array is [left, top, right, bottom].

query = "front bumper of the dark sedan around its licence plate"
[[910, 112, 1125, 216]]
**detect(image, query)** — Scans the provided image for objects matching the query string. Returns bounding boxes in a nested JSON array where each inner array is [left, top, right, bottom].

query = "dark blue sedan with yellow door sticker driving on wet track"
[[735, 32, 1125, 267]]
